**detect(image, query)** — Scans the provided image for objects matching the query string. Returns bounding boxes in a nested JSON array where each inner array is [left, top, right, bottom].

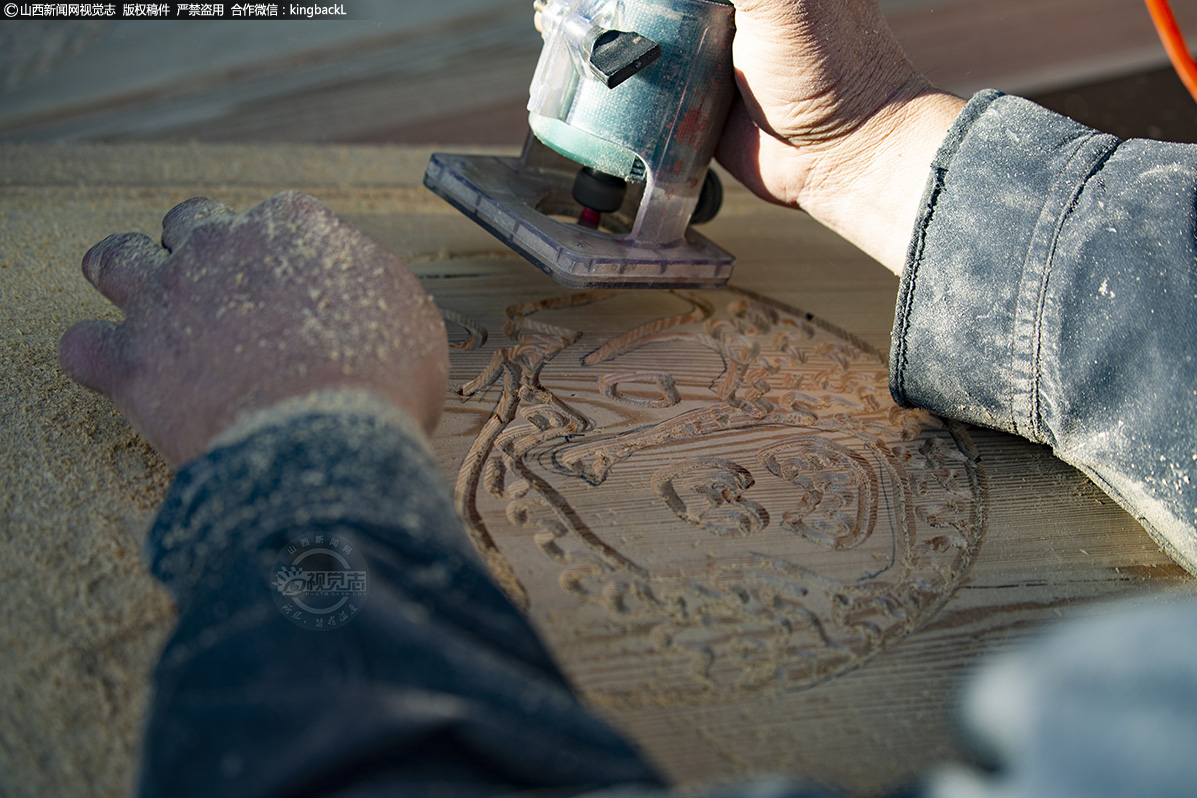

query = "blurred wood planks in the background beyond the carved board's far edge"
[[7, 0, 1197, 146]]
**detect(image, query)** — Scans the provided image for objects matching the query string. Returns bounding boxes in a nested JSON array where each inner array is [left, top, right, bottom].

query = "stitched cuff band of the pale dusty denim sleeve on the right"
[[889, 90, 1119, 443]]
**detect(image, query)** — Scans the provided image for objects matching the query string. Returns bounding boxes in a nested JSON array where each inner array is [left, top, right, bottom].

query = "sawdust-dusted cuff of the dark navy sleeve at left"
[[144, 391, 454, 611]]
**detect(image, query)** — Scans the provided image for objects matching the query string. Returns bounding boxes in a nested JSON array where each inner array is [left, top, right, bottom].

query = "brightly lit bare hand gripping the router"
[[718, 0, 964, 272]]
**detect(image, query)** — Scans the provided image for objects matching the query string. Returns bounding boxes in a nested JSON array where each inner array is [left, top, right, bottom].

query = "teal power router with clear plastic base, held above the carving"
[[424, 0, 735, 288]]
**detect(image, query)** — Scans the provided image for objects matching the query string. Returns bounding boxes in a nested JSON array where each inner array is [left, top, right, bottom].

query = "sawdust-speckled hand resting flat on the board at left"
[[59, 193, 448, 465]]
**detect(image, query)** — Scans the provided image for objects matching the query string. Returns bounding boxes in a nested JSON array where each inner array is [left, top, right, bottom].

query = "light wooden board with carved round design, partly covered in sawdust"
[[0, 145, 1193, 796]]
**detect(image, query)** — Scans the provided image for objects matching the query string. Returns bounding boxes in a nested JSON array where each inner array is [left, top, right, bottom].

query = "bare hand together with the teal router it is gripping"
[[425, 0, 964, 287]]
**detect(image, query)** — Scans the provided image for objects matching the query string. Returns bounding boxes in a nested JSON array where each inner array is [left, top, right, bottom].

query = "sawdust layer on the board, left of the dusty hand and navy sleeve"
[[0, 180, 172, 796]]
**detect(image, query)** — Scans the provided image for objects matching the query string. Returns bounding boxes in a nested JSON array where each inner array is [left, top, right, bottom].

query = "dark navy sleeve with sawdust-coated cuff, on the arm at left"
[[140, 396, 661, 797]]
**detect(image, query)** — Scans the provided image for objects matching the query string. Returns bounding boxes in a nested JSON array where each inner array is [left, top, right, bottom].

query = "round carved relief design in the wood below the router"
[[455, 291, 983, 703]]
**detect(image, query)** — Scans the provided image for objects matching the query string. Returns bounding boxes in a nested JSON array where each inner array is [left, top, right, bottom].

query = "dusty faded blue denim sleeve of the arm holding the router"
[[889, 91, 1197, 572]]
